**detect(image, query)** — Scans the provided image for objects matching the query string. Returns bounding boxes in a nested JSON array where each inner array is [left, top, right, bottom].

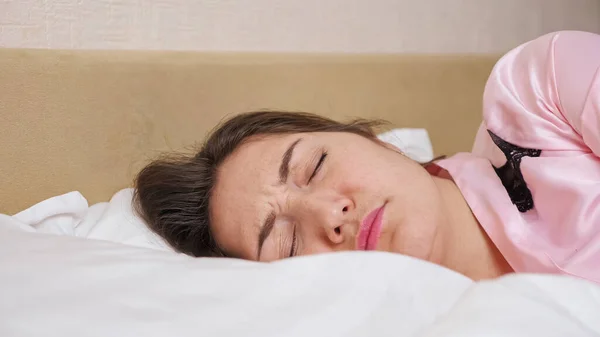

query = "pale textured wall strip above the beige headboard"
[[0, 0, 600, 52]]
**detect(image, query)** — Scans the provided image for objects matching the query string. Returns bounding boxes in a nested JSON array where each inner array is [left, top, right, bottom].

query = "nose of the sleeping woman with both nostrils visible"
[[298, 192, 353, 245]]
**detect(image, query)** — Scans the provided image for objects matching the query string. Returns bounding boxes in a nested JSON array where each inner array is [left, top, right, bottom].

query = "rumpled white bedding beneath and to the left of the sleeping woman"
[[0, 190, 600, 337]]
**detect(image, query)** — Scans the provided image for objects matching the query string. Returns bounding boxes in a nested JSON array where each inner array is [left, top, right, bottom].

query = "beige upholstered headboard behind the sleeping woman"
[[0, 49, 498, 213]]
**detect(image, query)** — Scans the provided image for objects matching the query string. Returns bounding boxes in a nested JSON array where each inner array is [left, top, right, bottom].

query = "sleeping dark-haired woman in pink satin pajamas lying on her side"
[[134, 32, 600, 282]]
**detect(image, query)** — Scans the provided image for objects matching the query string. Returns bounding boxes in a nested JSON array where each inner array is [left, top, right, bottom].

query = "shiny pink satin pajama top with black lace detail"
[[437, 31, 600, 283]]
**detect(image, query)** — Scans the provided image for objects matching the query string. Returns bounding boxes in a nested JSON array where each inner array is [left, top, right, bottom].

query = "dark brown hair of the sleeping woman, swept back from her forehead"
[[134, 111, 383, 257]]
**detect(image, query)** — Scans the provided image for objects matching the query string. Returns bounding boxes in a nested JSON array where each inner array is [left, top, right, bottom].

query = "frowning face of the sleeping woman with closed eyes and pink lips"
[[211, 132, 445, 261]]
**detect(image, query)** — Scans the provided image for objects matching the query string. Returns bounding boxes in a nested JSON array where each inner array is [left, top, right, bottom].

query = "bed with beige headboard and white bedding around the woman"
[[0, 49, 600, 337]]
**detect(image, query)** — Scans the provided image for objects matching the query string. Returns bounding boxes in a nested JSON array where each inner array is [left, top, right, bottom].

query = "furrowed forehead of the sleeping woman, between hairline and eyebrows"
[[211, 134, 302, 258]]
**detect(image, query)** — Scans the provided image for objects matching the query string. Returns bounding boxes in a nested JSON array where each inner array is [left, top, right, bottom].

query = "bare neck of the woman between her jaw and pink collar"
[[433, 177, 512, 281]]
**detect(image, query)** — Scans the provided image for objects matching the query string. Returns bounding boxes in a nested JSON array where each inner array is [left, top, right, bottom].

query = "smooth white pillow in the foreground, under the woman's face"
[[0, 215, 471, 337]]
